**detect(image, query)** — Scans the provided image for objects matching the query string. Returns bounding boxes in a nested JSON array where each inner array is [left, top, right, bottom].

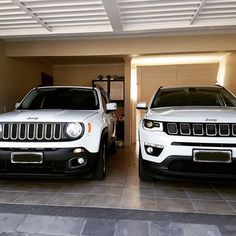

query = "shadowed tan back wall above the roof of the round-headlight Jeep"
[[53, 64, 124, 86]]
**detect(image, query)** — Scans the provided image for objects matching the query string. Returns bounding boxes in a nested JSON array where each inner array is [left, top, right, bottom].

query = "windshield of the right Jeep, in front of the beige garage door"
[[151, 87, 236, 108]]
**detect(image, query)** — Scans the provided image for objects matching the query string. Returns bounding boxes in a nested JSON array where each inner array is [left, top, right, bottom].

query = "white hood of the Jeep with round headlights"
[[0, 110, 98, 122]]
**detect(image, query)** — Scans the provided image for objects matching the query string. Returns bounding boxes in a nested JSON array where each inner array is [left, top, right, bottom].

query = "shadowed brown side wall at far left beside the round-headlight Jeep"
[[0, 41, 52, 113]]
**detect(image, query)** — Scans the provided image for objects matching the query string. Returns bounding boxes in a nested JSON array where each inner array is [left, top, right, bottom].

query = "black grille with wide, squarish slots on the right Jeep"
[[163, 122, 236, 137]]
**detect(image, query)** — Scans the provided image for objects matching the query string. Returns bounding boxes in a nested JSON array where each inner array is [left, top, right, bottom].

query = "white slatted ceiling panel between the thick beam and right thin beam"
[[119, 0, 200, 30]]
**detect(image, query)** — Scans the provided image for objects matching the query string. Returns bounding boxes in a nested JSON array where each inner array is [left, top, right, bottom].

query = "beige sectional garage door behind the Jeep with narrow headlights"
[[137, 63, 219, 102]]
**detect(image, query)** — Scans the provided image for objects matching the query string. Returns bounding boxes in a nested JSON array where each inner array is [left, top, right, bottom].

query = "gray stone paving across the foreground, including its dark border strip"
[[0, 208, 236, 236]]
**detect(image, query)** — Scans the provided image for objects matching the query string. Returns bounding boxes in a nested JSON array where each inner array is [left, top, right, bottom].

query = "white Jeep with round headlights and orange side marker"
[[0, 86, 116, 180]]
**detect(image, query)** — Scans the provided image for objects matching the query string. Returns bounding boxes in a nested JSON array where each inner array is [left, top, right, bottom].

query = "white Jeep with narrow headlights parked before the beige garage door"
[[137, 86, 236, 180]]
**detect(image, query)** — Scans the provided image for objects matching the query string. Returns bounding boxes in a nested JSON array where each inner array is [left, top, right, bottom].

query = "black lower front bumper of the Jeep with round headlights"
[[0, 148, 97, 176]]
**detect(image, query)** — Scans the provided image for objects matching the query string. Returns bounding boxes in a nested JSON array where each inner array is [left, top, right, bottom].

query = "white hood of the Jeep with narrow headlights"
[[145, 107, 236, 123]]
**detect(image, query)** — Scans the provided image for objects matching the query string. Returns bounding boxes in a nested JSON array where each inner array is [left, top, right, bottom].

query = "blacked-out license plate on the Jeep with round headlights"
[[11, 152, 43, 164]]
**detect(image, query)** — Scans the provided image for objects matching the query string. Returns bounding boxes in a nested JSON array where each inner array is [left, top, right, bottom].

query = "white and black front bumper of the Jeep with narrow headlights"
[[139, 128, 236, 178]]
